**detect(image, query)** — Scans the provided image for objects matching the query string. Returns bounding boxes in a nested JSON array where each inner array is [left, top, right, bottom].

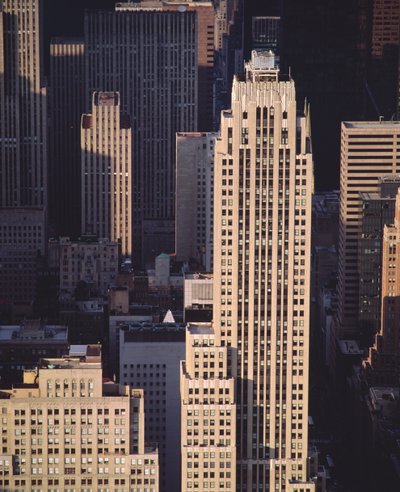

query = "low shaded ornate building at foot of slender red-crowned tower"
[[49, 235, 119, 298]]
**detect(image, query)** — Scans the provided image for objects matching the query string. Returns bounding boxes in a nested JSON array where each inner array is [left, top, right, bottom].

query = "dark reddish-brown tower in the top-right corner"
[[371, 0, 400, 58]]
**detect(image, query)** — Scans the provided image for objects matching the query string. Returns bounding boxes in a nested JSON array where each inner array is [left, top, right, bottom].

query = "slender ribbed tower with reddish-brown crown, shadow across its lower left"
[[81, 92, 132, 257]]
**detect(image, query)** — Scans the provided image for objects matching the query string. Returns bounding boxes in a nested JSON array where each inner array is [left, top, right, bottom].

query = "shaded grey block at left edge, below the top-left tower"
[[0, 208, 46, 305]]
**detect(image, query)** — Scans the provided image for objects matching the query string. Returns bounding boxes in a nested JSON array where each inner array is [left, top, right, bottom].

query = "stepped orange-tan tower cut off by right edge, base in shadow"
[[368, 192, 400, 386]]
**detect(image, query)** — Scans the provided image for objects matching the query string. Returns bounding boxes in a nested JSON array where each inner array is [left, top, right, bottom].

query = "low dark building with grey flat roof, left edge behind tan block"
[[0, 320, 69, 388]]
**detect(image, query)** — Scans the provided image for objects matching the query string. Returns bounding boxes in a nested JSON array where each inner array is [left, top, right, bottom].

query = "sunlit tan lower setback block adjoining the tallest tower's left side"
[[181, 323, 236, 492]]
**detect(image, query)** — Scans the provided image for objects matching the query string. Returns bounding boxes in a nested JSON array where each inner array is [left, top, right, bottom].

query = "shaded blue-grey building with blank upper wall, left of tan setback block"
[[119, 323, 185, 492]]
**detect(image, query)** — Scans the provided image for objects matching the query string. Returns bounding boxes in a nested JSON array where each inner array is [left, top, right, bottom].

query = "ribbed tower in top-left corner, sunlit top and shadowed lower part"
[[0, 0, 47, 207]]
